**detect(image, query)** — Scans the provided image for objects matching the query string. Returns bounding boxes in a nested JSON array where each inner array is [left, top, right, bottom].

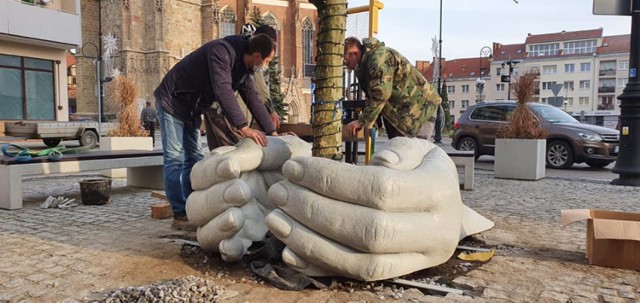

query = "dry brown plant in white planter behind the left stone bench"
[[100, 75, 153, 178]]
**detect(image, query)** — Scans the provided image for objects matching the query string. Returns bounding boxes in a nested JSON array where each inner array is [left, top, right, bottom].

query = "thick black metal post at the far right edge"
[[611, 0, 640, 186]]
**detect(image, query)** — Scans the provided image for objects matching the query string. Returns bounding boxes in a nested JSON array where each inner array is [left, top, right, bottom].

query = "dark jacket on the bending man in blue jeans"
[[154, 36, 276, 134]]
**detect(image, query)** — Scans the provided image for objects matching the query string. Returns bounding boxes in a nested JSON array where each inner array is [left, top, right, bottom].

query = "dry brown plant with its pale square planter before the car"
[[494, 74, 547, 180]]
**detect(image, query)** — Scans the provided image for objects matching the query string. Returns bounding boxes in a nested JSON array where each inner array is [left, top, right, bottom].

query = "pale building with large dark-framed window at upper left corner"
[[0, 0, 82, 132]]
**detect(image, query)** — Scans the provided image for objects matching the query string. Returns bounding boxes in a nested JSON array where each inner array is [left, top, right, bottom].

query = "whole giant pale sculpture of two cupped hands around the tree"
[[187, 137, 493, 281]]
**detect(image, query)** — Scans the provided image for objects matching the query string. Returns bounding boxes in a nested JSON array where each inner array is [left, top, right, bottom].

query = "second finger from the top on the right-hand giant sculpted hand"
[[269, 181, 462, 253]]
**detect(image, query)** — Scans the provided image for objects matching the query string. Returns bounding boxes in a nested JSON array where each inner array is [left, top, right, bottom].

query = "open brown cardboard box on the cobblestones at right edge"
[[562, 209, 640, 270]]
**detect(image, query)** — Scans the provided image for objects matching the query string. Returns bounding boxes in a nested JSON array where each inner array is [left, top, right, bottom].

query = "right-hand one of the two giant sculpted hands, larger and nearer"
[[266, 138, 493, 281]]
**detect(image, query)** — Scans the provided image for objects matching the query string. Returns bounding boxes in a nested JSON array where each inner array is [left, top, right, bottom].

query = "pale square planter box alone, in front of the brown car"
[[493, 139, 547, 181]]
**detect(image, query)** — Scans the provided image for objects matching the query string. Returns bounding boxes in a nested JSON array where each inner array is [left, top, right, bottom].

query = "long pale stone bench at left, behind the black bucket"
[[0, 150, 163, 210]]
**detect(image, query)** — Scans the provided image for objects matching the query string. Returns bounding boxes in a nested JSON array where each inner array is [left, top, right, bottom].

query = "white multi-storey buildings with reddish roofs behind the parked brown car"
[[418, 28, 630, 128]]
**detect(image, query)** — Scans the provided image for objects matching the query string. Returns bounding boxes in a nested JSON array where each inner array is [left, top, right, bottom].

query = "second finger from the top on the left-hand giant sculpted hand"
[[186, 179, 253, 226]]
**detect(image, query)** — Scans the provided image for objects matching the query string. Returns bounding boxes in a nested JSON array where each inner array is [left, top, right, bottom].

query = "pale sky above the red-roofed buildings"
[[349, 0, 631, 63]]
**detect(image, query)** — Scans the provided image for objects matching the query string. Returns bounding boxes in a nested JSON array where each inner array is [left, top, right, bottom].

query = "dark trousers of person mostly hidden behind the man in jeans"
[[203, 108, 243, 150]]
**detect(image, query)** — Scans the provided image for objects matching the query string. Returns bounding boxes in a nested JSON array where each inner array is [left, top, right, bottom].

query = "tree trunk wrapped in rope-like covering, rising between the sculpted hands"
[[311, 0, 347, 160]]
